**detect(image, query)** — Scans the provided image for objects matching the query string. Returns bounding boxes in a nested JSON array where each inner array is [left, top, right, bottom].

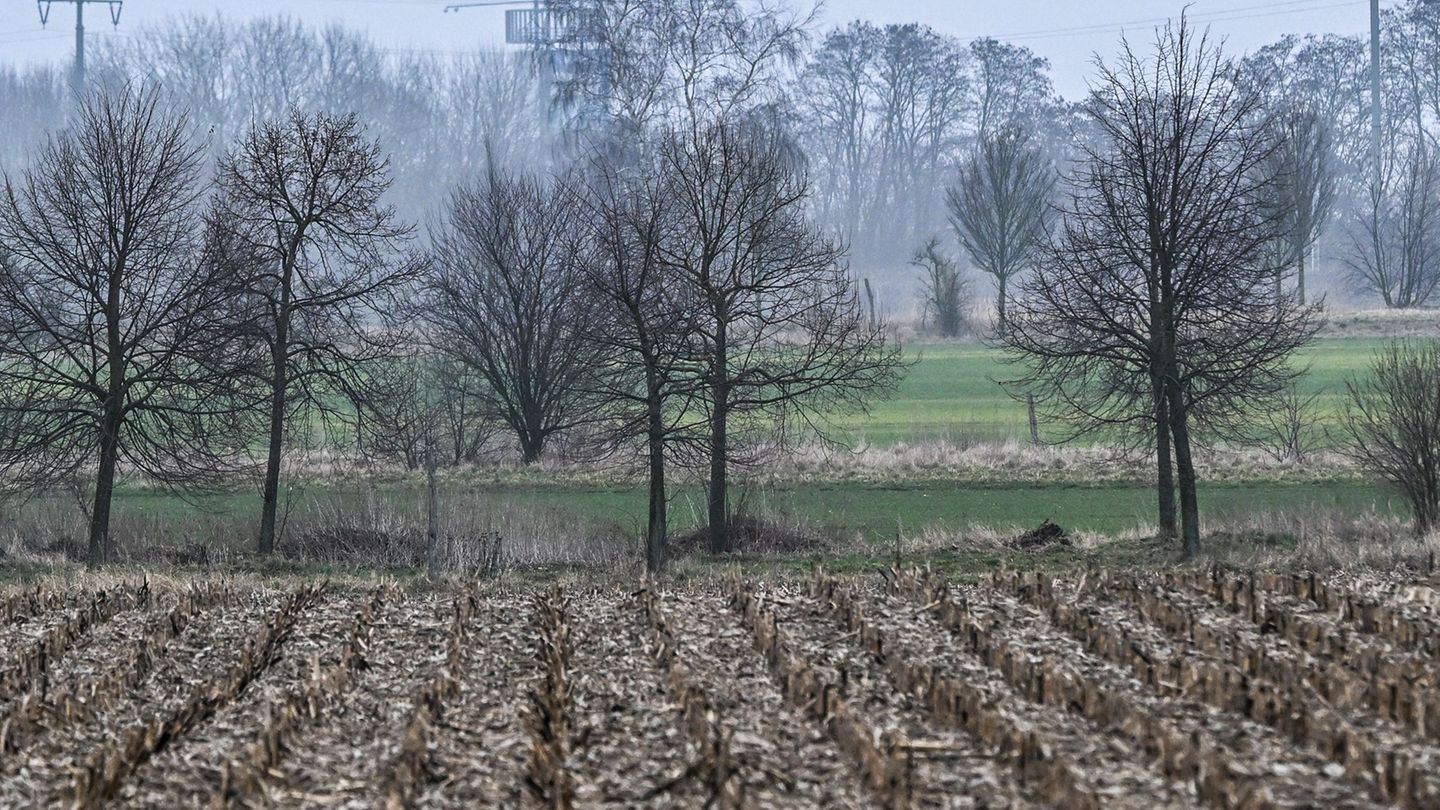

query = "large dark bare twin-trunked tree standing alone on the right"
[[1002, 19, 1319, 556]]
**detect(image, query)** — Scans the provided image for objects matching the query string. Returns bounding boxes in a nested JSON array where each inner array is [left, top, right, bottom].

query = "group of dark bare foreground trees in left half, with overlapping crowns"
[[0, 85, 900, 568]]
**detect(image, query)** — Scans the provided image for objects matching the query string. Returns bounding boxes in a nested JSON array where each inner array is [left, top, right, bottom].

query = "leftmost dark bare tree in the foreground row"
[[0, 89, 248, 566]]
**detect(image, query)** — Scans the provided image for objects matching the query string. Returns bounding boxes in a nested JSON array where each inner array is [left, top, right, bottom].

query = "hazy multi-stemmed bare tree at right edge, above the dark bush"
[[1345, 144, 1440, 308]]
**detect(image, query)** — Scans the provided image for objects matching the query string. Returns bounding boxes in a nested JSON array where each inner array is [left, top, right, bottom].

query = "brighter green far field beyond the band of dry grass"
[[835, 337, 1387, 445]]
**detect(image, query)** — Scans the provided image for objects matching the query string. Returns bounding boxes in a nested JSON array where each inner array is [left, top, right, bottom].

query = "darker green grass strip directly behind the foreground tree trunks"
[[70, 481, 1407, 548]]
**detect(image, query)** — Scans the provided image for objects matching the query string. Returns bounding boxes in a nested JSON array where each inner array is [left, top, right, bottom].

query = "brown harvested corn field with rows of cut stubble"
[[0, 571, 1440, 809]]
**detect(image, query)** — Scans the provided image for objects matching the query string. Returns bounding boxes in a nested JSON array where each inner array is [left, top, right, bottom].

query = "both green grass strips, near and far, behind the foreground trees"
[[2, 332, 1408, 562]]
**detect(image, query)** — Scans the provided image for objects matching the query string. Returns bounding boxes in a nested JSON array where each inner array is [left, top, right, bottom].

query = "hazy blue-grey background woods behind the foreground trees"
[[0, 0, 1440, 307]]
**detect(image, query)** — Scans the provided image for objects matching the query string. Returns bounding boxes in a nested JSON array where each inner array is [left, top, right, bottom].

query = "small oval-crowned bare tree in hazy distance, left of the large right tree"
[[946, 128, 1056, 333]]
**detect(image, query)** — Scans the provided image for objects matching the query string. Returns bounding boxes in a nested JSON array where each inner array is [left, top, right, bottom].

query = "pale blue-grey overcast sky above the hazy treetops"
[[0, 0, 1370, 99]]
